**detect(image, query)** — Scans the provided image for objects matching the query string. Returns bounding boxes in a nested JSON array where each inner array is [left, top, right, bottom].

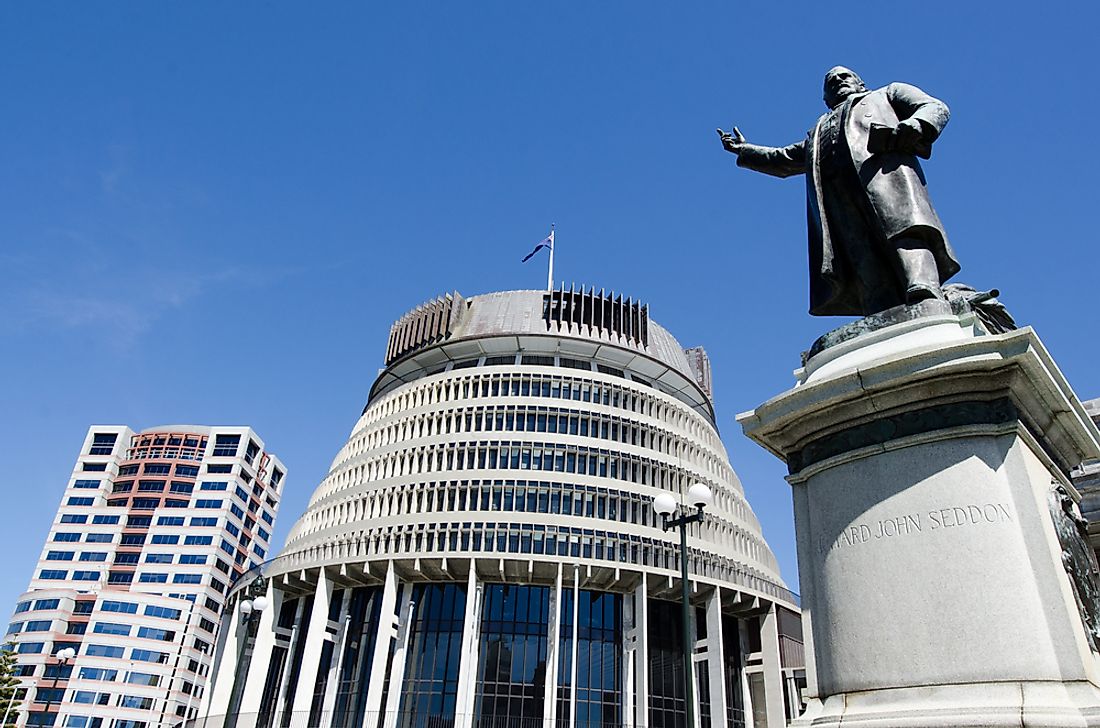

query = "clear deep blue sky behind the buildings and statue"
[[0, 2, 1100, 603]]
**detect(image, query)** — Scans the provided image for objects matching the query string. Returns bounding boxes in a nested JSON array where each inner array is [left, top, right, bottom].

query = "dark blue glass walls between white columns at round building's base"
[[210, 582, 793, 728]]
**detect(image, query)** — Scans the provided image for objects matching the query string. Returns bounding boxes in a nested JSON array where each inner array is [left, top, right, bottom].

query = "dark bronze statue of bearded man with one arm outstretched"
[[718, 66, 959, 316]]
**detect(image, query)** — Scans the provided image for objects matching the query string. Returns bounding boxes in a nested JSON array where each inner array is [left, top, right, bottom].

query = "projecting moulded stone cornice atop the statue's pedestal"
[[737, 317, 1100, 474]]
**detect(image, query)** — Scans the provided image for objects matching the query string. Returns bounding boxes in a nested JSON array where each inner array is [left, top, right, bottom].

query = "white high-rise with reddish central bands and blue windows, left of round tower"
[[6, 426, 286, 728]]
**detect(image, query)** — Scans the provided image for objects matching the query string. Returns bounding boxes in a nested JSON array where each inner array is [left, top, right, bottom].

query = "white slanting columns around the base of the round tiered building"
[[197, 560, 792, 728]]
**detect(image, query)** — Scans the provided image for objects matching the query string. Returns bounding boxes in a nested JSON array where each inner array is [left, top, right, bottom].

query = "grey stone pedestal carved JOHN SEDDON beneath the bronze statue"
[[738, 301, 1100, 727]]
